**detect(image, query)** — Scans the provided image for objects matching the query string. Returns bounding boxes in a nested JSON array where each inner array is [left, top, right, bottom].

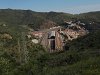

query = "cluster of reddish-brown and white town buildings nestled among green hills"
[[27, 21, 89, 52]]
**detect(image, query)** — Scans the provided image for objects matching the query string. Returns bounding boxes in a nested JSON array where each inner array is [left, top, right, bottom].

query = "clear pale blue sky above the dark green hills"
[[0, 0, 100, 14]]
